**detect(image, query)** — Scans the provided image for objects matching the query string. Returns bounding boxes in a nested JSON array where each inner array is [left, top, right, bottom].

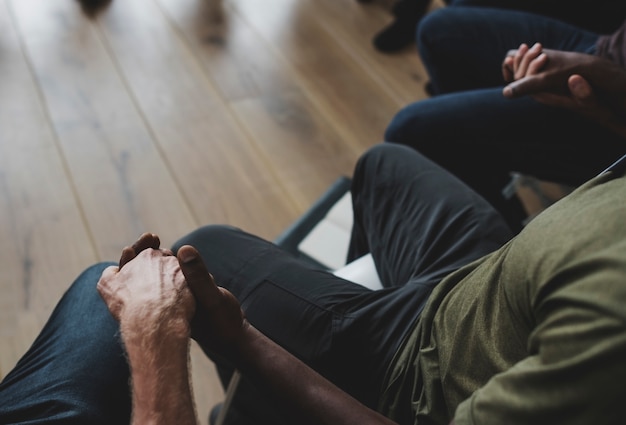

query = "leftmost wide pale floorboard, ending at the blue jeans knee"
[[0, 1, 97, 374]]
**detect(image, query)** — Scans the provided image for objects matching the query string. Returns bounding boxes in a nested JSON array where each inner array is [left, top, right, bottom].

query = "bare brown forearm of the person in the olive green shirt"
[[229, 325, 394, 425]]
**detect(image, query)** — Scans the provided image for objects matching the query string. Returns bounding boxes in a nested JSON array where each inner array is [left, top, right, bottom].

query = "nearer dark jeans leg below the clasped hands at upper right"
[[385, 88, 623, 230]]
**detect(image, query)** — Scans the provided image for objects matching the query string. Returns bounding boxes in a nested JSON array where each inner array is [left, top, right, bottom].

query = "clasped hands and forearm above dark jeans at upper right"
[[502, 43, 626, 137]]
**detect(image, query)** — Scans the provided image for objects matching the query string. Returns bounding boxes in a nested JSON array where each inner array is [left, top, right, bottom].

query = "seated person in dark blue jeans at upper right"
[[385, 11, 626, 232]]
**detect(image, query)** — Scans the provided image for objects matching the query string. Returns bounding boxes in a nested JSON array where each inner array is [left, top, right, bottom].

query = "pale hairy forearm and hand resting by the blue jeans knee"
[[97, 242, 197, 425]]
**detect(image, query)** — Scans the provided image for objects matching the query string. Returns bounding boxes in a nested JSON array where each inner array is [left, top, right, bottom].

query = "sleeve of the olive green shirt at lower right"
[[455, 248, 626, 425]]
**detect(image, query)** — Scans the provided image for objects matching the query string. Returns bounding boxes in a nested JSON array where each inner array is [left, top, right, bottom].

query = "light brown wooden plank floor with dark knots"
[[0, 0, 425, 422]]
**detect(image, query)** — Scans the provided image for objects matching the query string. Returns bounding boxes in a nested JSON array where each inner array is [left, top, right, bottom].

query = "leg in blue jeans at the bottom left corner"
[[0, 264, 130, 424]]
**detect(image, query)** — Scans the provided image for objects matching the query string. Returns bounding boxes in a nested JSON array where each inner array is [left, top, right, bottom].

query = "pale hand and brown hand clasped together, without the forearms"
[[97, 233, 247, 354]]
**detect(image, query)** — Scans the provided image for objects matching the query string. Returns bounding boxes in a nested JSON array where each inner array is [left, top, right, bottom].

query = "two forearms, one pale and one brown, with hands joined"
[[98, 234, 393, 425]]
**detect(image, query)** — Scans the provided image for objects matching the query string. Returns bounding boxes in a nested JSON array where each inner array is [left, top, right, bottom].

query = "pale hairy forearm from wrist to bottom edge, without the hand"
[[122, 322, 197, 425]]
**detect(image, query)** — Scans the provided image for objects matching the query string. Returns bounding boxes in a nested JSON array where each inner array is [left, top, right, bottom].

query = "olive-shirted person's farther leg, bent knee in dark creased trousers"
[[349, 144, 512, 289]]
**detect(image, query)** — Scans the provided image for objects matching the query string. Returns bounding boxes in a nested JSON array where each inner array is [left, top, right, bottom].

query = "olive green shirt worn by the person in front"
[[380, 170, 626, 425]]
